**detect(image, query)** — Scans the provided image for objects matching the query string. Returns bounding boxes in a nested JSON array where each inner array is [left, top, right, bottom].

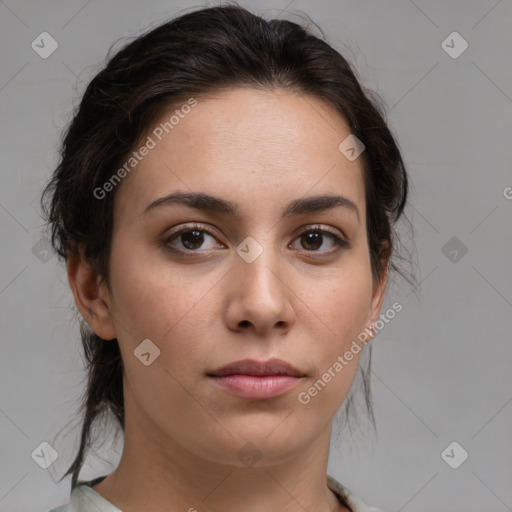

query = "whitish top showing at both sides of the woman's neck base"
[[49, 475, 381, 512]]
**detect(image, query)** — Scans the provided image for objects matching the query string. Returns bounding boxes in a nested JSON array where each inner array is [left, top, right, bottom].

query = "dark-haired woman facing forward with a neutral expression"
[[42, 6, 408, 512]]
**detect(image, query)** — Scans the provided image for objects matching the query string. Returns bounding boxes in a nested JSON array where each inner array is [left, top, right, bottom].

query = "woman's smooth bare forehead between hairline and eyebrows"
[[116, 88, 364, 223]]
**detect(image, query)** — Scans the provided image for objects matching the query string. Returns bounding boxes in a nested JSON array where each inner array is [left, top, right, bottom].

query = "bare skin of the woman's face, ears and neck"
[[68, 88, 387, 512]]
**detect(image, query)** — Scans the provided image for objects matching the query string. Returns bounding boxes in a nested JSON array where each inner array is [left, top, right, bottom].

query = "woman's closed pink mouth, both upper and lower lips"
[[207, 359, 306, 400]]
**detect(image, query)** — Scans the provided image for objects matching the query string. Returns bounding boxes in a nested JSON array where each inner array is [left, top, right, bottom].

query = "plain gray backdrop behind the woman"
[[0, 0, 512, 512]]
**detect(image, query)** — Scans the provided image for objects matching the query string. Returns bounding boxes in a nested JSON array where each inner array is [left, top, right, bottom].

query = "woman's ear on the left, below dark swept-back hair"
[[67, 248, 116, 340]]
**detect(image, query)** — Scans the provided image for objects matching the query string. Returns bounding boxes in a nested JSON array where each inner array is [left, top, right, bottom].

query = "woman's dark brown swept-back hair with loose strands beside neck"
[[41, 5, 411, 488]]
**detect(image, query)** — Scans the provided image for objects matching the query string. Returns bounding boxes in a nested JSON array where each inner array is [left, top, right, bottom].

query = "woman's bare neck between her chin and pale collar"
[[93, 386, 346, 512]]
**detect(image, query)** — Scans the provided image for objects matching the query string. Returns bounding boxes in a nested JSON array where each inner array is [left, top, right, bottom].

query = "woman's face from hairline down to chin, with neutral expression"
[[97, 89, 383, 466]]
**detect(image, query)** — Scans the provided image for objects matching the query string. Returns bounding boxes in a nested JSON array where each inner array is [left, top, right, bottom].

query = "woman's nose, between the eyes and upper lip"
[[224, 243, 295, 336]]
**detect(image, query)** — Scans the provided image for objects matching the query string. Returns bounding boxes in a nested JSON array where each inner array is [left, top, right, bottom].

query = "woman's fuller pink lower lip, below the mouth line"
[[212, 375, 300, 400]]
